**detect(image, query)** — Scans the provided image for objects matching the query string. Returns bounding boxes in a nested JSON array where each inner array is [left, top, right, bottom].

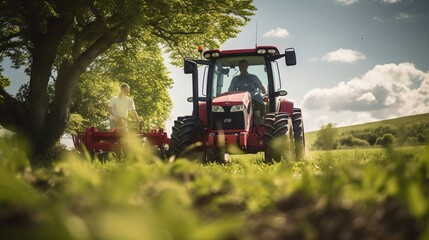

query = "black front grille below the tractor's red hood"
[[212, 107, 247, 130]]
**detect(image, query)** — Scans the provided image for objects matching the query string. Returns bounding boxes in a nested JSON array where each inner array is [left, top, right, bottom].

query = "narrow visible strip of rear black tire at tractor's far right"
[[292, 108, 305, 160]]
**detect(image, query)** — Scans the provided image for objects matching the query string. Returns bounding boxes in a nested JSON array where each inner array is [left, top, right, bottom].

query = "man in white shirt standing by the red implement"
[[107, 84, 140, 130]]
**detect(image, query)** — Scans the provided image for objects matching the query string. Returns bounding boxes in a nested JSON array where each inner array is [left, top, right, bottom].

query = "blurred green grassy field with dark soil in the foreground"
[[0, 138, 429, 240]]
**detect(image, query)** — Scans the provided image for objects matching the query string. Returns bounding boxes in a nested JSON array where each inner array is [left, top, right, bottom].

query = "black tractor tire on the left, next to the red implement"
[[169, 116, 205, 159]]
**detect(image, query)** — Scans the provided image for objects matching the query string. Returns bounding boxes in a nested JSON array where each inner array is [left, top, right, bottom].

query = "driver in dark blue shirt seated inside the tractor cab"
[[228, 59, 267, 94]]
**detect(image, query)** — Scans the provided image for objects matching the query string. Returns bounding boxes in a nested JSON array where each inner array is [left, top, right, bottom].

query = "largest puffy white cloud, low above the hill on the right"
[[301, 63, 429, 119]]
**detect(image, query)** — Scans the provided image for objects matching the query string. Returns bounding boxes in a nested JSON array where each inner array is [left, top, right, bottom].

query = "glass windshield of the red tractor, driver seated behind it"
[[212, 56, 268, 98]]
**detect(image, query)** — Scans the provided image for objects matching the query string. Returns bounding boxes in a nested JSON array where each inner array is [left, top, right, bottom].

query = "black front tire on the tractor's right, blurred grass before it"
[[264, 112, 294, 163]]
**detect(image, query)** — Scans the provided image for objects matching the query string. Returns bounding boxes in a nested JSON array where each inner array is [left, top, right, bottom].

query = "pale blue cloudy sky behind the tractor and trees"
[[4, 0, 429, 133]]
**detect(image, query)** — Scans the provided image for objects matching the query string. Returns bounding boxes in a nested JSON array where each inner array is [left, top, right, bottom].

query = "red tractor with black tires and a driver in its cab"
[[169, 46, 305, 163]]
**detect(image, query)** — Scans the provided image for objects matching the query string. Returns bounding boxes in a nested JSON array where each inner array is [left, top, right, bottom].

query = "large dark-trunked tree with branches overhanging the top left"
[[0, 0, 255, 161]]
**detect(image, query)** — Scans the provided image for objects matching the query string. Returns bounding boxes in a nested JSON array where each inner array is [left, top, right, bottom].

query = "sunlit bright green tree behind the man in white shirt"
[[70, 43, 173, 129]]
